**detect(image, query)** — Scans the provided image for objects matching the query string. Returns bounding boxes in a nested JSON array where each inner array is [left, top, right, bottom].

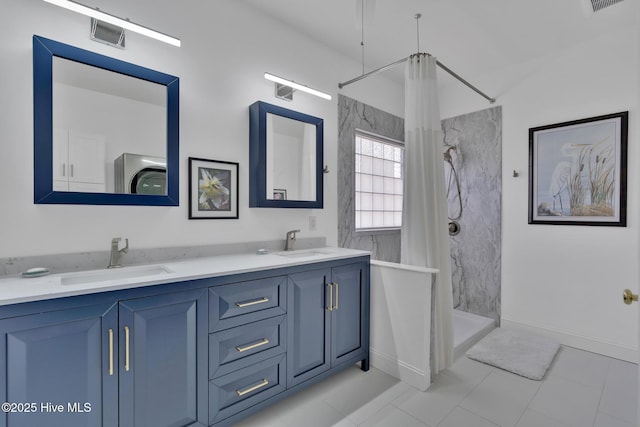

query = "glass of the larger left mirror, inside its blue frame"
[[53, 57, 167, 195]]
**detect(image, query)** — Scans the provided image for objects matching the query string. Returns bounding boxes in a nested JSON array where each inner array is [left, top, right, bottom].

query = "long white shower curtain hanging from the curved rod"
[[401, 54, 453, 374]]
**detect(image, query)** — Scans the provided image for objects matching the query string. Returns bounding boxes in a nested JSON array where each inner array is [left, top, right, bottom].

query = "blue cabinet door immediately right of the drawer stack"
[[287, 269, 331, 387]]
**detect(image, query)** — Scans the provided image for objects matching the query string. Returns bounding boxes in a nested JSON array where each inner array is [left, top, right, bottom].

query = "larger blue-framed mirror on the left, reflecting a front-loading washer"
[[33, 35, 180, 206]]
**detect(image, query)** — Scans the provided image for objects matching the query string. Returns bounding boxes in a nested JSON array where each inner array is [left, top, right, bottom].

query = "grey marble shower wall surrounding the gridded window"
[[338, 95, 404, 262]]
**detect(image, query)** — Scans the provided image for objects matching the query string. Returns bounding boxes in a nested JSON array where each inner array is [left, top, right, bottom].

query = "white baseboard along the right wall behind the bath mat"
[[500, 317, 638, 363]]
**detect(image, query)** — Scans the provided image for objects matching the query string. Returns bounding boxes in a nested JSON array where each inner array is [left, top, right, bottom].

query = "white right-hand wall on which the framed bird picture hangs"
[[440, 29, 640, 360]]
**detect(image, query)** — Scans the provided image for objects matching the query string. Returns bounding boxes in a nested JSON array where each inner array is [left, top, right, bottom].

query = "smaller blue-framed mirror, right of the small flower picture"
[[249, 101, 324, 209]]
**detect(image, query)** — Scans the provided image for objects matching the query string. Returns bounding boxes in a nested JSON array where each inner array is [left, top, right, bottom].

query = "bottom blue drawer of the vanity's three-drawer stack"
[[209, 354, 286, 424]]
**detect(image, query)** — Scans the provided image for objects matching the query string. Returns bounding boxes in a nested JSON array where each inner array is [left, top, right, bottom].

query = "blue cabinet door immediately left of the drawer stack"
[[119, 289, 208, 427]]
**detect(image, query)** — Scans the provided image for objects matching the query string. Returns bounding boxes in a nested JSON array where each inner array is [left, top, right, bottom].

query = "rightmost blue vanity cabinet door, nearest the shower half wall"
[[331, 263, 368, 366]]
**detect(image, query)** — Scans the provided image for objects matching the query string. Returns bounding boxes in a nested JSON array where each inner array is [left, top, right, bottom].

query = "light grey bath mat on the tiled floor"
[[466, 328, 560, 380]]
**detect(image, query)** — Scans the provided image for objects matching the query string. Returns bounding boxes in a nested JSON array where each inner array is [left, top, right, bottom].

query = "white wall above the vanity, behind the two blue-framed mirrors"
[[0, 0, 402, 257]]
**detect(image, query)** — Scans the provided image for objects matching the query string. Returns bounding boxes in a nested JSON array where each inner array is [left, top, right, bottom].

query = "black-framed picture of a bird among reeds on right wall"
[[529, 111, 629, 227]]
